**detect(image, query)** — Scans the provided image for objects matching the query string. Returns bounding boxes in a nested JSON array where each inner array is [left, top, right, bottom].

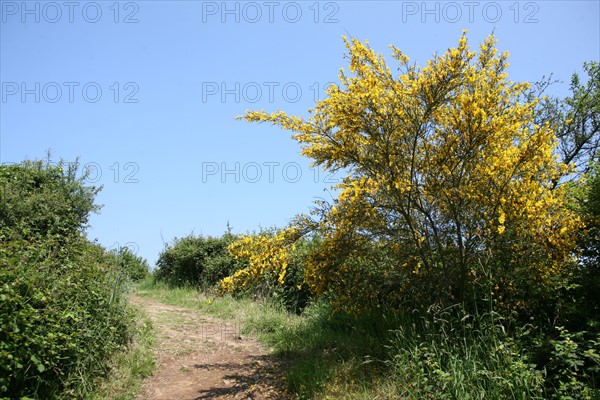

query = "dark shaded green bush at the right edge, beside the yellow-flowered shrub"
[[531, 162, 600, 399]]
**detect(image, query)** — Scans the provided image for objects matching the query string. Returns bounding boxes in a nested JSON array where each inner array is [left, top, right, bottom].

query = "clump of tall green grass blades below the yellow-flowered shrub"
[[387, 309, 544, 400]]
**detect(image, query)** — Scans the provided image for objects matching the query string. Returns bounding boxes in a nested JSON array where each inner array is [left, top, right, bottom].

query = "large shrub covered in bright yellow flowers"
[[222, 32, 580, 312]]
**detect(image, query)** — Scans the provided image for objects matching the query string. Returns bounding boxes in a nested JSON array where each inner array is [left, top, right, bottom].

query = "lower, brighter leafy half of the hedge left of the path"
[[0, 241, 129, 398]]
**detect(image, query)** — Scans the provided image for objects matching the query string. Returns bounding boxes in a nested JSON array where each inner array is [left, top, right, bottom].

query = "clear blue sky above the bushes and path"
[[0, 0, 600, 264]]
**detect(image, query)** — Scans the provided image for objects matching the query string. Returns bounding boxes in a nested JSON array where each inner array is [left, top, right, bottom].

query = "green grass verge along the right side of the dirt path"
[[137, 280, 543, 400]]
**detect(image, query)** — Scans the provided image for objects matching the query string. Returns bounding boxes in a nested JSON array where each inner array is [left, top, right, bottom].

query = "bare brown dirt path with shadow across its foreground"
[[131, 296, 291, 400]]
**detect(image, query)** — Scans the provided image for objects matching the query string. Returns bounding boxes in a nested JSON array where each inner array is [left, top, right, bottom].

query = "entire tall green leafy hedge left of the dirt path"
[[0, 161, 135, 399]]
